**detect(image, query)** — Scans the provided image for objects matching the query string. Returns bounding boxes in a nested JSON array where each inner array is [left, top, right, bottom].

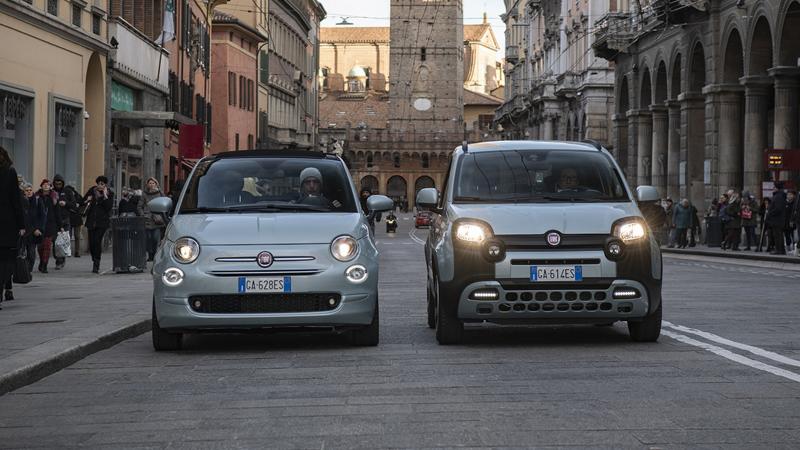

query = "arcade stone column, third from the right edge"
[[717, 85, 744, 192]]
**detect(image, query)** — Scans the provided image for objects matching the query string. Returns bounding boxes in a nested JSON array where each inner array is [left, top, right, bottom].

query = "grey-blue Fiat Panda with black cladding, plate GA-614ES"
[[417, 141, 662, 344]]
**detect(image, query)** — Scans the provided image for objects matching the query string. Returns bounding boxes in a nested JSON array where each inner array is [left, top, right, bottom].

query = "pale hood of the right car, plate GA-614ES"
[[450, 203, 641, 235]]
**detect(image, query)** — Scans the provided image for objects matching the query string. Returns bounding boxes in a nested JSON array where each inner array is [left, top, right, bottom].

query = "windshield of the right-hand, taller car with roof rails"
[[453, 150, 630, 203]]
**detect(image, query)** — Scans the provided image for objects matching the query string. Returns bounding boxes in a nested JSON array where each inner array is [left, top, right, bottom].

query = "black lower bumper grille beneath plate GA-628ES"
[[189, 294, 342, 314]]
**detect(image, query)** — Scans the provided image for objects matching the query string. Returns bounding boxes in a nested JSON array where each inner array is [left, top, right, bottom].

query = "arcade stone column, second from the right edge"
[[740, 76, 772, 197]]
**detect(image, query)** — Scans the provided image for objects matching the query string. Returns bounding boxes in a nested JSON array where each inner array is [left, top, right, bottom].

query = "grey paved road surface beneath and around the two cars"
[[0, 214, 800, 448]]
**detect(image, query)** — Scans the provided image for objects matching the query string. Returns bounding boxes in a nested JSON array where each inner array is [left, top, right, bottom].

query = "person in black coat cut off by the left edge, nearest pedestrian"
[[0, 147, 25, 309]]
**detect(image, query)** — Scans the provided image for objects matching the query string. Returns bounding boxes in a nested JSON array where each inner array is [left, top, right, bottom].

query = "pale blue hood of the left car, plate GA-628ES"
[[167, 213, 367, 245]]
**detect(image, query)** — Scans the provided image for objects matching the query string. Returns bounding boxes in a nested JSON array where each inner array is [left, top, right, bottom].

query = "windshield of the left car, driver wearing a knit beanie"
[[179, 157, 357, 214]]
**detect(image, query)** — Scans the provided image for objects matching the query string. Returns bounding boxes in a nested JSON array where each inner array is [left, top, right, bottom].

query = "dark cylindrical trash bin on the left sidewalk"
[[111, 216, 147, 273]]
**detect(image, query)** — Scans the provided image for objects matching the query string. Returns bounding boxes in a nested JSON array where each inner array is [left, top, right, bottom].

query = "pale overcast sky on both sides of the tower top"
[[321, 0, 505, 54]]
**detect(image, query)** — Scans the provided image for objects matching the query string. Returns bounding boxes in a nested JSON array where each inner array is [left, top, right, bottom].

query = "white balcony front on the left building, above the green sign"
[[108, 19, 169, 94]]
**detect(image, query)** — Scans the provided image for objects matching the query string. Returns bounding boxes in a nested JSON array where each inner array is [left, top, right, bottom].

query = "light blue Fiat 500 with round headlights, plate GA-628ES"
[[150, 151, 392, 350]]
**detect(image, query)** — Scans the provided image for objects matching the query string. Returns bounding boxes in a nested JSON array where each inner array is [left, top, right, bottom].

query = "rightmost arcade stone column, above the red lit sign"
[[769, 67, 800, 149]]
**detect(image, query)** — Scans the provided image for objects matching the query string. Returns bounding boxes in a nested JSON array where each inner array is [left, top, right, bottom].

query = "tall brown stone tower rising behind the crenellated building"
[[389, 0, 464, 137]]
